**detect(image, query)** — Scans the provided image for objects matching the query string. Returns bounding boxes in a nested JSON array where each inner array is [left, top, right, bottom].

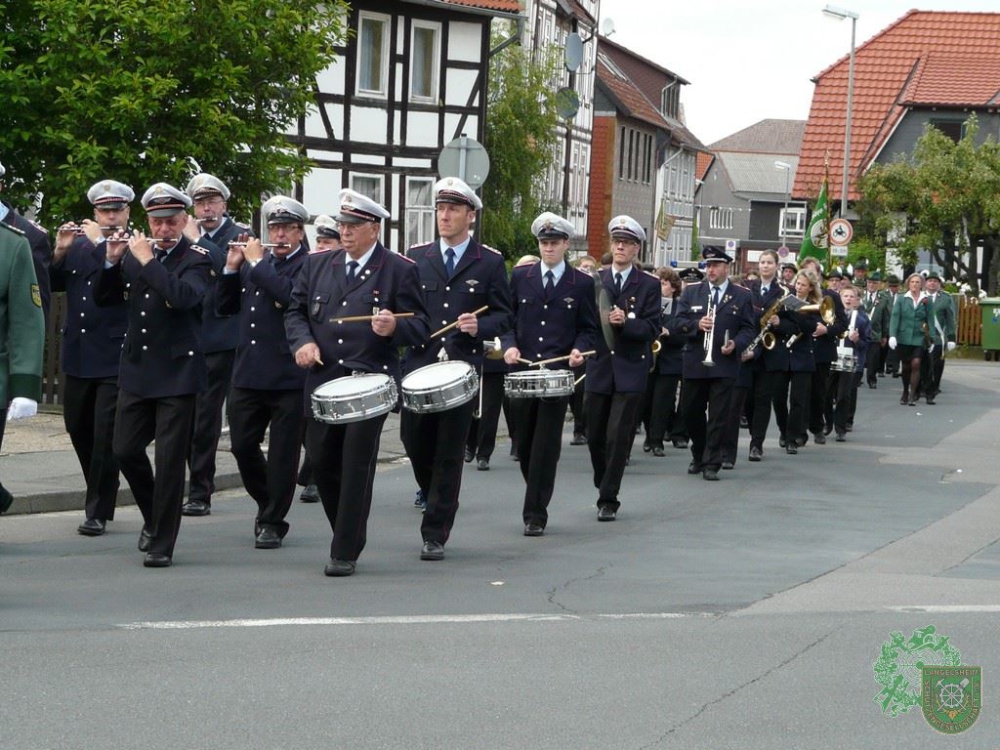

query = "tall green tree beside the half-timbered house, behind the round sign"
[[480, 24, 559, 258]]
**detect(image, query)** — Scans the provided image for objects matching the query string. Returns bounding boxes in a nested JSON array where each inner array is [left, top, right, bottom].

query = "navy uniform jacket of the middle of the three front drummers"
[[403, 238, 513, 373]]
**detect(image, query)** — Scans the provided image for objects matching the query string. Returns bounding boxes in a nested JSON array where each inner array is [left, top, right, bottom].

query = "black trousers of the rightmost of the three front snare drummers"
[[510, 396, 570, 528]]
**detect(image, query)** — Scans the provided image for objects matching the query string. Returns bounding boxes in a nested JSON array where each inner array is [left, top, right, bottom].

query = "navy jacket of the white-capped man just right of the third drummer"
[[583, 268, 660, 394]]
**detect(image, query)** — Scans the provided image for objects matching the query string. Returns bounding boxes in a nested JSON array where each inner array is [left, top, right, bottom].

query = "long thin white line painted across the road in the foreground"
[[116, 612, 715, 630]]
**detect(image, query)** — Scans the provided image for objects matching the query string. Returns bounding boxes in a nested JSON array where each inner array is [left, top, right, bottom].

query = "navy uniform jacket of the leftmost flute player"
[[49, 237, 128, 378]]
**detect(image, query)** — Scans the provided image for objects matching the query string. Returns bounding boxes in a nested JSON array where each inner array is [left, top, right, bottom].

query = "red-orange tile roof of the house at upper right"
[[793, 10, 1000, 200]]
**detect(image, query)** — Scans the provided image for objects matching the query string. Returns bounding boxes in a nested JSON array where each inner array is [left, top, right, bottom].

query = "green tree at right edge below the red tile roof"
[[859, 115, 1000, 293]]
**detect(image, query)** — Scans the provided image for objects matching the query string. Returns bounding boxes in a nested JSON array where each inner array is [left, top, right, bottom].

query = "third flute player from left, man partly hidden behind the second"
[[181, 173, 244, 516]]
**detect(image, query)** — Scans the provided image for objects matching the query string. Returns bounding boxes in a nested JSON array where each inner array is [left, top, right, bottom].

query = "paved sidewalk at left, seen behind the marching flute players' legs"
[[0, 412, 410, 515]]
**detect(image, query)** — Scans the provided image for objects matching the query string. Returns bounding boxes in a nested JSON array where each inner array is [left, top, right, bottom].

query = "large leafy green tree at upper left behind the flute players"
[[0, 0, 346, 222]]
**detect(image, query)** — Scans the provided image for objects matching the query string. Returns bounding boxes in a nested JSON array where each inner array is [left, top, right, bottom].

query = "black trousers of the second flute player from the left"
[[114, 390, 195, 557]]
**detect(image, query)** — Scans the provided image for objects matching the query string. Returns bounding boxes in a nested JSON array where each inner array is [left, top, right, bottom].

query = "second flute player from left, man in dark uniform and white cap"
[[97, 182, 212, 568]]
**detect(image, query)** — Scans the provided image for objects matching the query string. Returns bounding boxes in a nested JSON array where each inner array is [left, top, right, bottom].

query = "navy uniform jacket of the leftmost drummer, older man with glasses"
[[285, 243, 431, 414]]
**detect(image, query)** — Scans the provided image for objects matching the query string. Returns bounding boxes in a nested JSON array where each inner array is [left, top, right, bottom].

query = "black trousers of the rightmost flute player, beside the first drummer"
[[228, 386, 305, 537]]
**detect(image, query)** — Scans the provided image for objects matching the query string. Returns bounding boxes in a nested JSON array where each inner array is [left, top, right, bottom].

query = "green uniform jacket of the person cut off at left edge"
[[0, 223, 45, 409]]
